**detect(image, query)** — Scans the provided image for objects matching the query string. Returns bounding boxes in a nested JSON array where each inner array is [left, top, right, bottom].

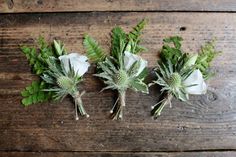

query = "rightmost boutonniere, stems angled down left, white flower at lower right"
[[150, 36, 219, 118]]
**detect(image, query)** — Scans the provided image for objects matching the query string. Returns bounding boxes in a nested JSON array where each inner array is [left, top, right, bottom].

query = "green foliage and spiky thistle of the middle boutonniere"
[[90, 20, 148, 93]]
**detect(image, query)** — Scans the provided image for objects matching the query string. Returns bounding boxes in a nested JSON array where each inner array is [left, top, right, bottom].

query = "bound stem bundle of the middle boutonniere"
[[111, 91, 126, 120]]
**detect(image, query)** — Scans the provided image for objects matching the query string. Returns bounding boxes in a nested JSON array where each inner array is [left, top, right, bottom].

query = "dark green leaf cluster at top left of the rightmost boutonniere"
[[160, 36, 183, 64]]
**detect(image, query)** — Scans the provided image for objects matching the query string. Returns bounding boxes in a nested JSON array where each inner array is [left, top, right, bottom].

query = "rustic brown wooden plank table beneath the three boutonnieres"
[[0, 0, 236, 157]]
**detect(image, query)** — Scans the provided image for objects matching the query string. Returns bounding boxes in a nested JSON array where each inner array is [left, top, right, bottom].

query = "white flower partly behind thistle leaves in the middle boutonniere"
[[124, 51, 147, 76]]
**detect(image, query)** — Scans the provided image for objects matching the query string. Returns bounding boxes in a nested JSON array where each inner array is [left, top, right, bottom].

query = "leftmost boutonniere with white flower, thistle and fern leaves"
[[21, 37, 90, 120]]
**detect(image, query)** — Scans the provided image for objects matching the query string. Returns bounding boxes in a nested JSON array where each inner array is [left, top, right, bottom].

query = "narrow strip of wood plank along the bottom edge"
[[0, 151, 236, 157]]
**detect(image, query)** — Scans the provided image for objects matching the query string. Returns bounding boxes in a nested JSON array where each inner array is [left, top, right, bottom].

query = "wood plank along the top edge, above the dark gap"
[[0, 0, 236, 13]]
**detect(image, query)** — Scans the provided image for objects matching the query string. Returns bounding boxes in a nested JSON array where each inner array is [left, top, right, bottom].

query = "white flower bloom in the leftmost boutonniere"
[[59, 53, 90, 76]]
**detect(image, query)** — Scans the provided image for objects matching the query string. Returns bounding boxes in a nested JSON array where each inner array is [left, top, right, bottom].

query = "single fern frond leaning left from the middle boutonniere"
[[83, 35, 106, 63]]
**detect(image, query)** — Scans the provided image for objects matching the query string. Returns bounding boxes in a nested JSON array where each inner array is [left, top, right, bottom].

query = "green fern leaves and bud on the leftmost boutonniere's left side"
[[21, 37, 66, 106]]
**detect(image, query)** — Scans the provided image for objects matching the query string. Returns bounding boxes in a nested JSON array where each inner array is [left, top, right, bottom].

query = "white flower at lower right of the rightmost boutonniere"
[[183, 69, 207, 95]]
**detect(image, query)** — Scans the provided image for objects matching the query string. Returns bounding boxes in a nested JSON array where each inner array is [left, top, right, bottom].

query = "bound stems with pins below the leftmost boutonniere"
[[73, 91, 89, 120]]
